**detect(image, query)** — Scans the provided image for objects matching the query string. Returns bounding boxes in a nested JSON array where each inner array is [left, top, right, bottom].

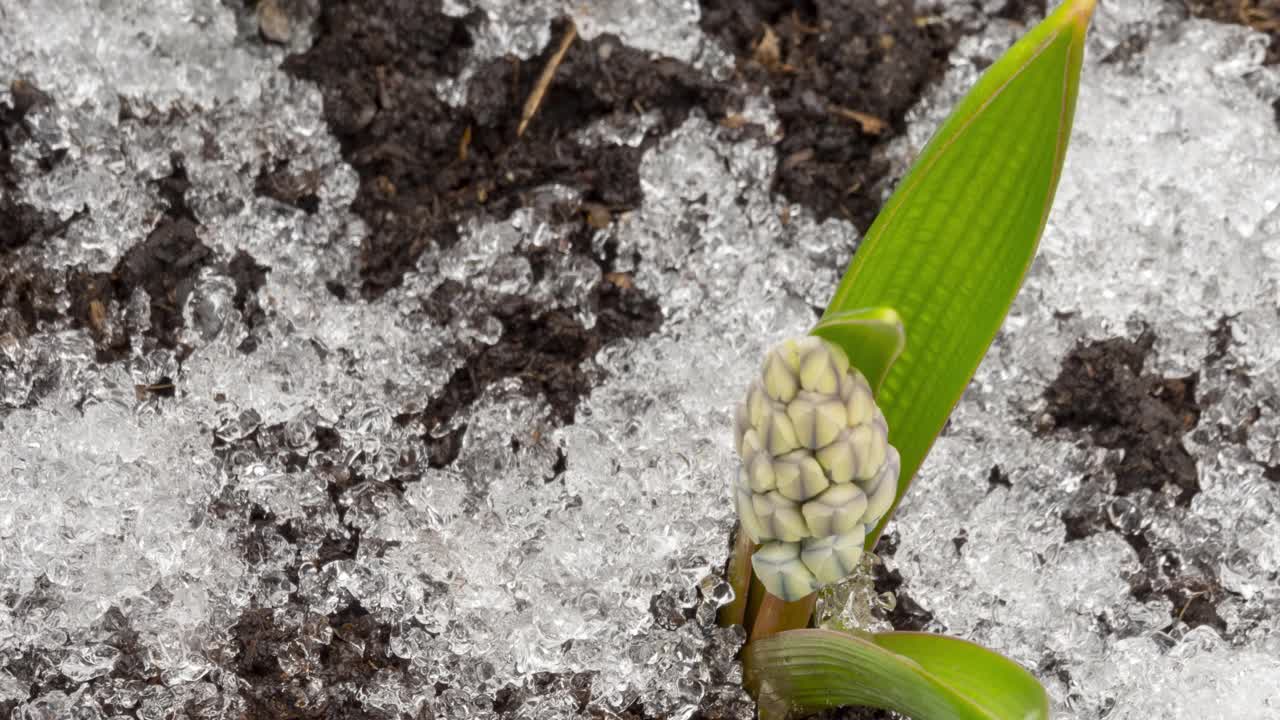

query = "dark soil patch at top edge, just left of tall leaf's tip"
[[701, 0, 957, 232]]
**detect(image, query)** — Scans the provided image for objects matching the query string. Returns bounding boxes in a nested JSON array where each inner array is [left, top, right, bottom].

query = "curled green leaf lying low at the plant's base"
[[742, 630, 1048, 720]]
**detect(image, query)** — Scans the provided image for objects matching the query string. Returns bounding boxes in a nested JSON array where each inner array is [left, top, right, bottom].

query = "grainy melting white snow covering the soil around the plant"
[[0, 0, 1280, 719]]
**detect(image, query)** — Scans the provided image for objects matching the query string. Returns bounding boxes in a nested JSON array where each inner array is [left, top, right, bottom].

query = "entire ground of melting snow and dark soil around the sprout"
[[0, 0, 1280, 719]]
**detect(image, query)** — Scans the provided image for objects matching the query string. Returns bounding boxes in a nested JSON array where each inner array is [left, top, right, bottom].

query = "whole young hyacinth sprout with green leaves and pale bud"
[[719, 0, 1096, 720]]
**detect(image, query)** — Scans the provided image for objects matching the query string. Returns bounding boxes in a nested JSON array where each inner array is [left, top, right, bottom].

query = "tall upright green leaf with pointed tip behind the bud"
[[819, 0, 1096, 548]]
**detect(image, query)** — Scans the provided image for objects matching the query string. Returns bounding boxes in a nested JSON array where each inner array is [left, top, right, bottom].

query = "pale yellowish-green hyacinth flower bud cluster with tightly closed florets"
[[733, 337, 901, 602]]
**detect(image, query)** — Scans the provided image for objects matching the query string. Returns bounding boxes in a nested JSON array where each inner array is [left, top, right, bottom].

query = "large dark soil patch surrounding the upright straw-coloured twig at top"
[[285, 0, 731, 297]]
